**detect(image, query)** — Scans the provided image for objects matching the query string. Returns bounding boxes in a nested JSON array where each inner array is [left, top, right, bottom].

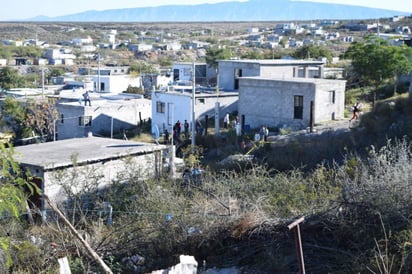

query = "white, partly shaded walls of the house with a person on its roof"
[[57, 98, 152, 140]]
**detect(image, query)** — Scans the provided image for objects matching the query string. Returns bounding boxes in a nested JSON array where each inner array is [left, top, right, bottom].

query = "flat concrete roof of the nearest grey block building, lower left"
[[14, 137, 167, 170]]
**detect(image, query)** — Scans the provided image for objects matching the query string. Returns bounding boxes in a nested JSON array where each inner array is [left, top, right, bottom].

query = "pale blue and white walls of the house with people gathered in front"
[[152, 92, 238, 132]]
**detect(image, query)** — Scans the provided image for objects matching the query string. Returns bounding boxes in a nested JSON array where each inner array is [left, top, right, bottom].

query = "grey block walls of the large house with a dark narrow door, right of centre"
[[239, 78, 345, 129]]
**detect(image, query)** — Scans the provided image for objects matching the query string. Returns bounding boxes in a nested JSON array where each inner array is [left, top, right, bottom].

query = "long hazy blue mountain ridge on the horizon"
[[27, 0, 409, 22]]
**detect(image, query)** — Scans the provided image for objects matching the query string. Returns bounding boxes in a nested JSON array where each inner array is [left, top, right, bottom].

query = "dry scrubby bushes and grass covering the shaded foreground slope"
[[0, 89, 412, 273]]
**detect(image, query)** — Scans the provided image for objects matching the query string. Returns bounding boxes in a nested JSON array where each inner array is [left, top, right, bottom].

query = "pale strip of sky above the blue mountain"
[[0, 0, 412, 21]]
